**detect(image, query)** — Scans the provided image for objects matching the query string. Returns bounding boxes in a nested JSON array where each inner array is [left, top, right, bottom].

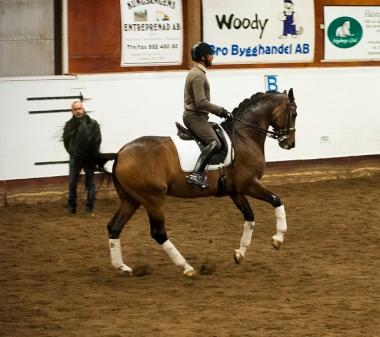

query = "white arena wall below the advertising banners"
[[0, 67, 380, 180]]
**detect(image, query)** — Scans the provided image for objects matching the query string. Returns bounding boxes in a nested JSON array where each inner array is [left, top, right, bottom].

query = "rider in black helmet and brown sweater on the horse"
[[183, 42, 231, 188]]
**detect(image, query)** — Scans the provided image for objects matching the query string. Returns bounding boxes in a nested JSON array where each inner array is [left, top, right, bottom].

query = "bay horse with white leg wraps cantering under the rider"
[[107, 89, 297, 277]]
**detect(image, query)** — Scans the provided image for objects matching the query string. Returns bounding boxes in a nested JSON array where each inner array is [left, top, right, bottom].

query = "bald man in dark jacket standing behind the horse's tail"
[[62, 101, 102, 215]]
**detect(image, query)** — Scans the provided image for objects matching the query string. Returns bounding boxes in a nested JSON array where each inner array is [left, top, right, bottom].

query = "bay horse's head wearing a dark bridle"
[[270, 89, 297, 150]]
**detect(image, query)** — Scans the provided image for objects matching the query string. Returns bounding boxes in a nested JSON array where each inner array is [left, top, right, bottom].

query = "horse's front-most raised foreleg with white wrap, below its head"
[[249, 180, 288, 249]]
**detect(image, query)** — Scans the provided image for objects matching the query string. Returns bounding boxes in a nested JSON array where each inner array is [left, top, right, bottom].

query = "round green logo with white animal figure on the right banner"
[[327, 16, 363, 48]]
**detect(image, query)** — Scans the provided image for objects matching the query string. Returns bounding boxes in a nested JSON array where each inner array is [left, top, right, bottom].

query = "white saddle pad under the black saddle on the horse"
[[170, 128, 234, 172]]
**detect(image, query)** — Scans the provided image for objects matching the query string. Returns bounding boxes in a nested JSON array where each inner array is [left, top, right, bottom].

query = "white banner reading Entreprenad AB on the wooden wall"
[[120, 0, 183, 67]]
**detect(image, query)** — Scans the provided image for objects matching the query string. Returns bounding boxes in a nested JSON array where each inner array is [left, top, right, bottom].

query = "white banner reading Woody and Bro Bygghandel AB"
[[202, 0, 315, 64]]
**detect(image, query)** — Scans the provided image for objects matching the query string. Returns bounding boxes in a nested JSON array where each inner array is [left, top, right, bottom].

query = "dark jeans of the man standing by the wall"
[[68, 157, 96, 211]]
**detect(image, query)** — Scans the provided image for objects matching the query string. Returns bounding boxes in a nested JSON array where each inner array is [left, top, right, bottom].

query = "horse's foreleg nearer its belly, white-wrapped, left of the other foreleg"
[[230, 195, 255, 264]]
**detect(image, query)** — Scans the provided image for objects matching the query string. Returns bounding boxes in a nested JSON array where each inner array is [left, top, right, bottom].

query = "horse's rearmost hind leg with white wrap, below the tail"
[[107, 194, 140, 275]]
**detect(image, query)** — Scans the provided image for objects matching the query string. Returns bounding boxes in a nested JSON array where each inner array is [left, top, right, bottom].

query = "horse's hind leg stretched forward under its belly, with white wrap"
[[144, 198, 196, 277]]
